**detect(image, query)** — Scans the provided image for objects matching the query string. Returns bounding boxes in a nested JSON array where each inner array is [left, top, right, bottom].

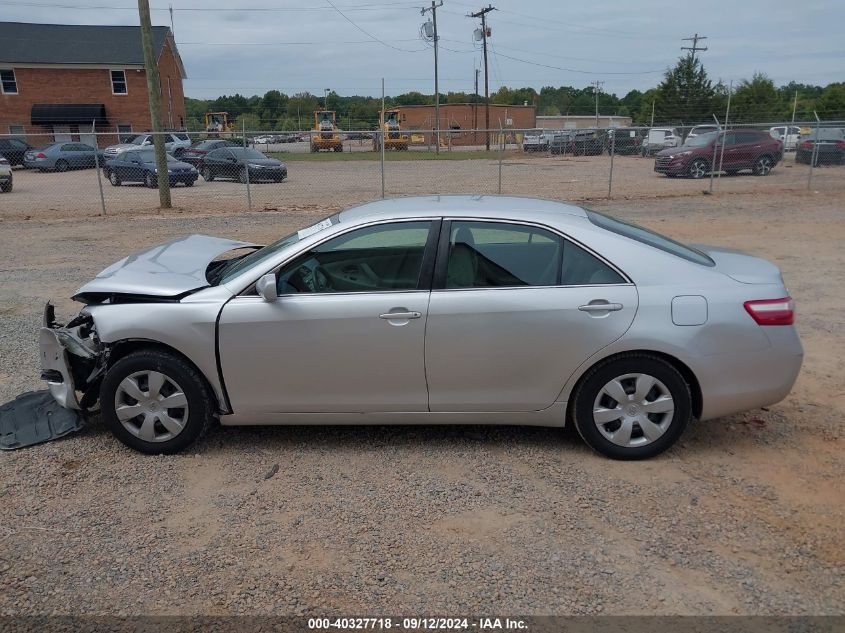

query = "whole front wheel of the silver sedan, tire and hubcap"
[[100, 350, 214, 454]]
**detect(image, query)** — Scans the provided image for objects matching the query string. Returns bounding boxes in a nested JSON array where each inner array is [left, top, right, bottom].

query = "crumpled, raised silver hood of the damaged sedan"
[[73, 235, 257, 303]]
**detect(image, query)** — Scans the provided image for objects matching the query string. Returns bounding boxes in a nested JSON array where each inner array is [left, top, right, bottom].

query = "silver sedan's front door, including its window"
[[219, 220, 439, 416]]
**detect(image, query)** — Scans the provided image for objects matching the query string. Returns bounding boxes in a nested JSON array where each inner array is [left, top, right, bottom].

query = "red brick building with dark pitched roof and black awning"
[[0, 22, 186, 146]]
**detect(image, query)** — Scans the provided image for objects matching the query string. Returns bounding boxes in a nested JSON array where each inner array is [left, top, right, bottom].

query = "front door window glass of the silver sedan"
[[277, 221, 431, 294]]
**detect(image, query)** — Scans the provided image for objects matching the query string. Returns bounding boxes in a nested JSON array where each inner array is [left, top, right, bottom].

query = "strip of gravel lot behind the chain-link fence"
[[0, 151, 845, 219]]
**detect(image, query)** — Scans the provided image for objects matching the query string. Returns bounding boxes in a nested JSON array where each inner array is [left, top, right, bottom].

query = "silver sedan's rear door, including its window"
[[425, 221, 637, 411]]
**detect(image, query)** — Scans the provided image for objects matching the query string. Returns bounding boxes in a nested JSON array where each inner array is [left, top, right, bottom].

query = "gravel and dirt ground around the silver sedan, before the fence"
[[0, 190, 845, 615]]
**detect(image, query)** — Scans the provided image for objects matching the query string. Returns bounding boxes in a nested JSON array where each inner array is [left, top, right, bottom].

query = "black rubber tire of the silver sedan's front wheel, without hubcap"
[[100, 349, 214, 455]]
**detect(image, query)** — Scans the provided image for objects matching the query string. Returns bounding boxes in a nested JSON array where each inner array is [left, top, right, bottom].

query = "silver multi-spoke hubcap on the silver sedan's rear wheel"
[[593, 374, 675, 447]]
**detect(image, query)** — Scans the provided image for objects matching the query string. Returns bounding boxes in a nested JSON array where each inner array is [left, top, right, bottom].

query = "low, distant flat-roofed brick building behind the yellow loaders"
[[396, 103, 535, 145]]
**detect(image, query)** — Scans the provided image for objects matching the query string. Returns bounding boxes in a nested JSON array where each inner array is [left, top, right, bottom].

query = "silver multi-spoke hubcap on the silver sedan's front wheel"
[[114, 371, 188, 442]]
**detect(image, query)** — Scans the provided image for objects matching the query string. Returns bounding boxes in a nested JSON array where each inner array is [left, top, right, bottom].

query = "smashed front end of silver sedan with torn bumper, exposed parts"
[[39, 302, 108, 410]]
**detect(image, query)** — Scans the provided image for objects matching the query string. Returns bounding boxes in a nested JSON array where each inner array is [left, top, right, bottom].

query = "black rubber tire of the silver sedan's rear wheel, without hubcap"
[[570, 353, 692, 460]]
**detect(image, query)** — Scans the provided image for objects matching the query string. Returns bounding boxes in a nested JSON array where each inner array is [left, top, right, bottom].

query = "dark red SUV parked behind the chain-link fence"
[[654, 130, 783, 178]]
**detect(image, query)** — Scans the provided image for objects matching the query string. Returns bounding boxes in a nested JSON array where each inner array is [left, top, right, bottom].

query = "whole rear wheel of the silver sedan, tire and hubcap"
[[571, 354, 692, 459]]
